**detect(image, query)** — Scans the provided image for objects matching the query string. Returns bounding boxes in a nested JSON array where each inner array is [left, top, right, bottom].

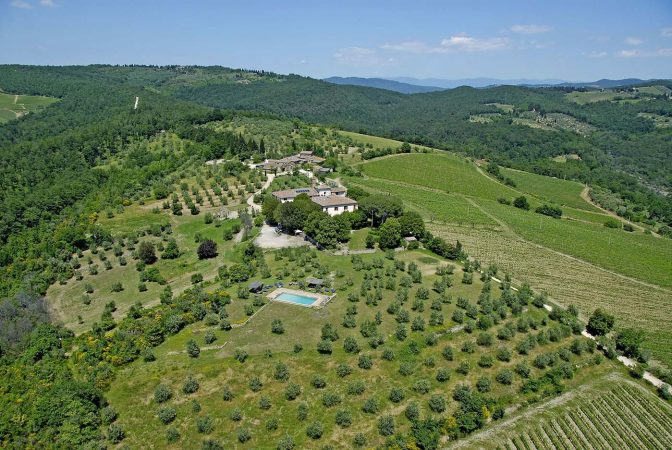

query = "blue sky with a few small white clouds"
[[0, 0, 672, 80]]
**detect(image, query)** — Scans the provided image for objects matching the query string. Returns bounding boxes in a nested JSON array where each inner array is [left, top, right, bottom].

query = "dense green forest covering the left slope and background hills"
[[0, 66, 672, 448]]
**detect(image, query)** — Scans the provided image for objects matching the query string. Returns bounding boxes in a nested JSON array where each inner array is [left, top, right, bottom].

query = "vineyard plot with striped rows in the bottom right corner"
[[456, 377, 672, 450]]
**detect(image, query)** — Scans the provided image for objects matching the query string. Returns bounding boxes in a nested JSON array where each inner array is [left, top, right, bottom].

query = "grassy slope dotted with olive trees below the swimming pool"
[[108, 246, 618, 448]]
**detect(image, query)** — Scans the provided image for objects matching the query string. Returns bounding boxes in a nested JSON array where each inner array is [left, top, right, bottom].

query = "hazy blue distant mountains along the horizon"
[[323, 77, 651, 94]]
